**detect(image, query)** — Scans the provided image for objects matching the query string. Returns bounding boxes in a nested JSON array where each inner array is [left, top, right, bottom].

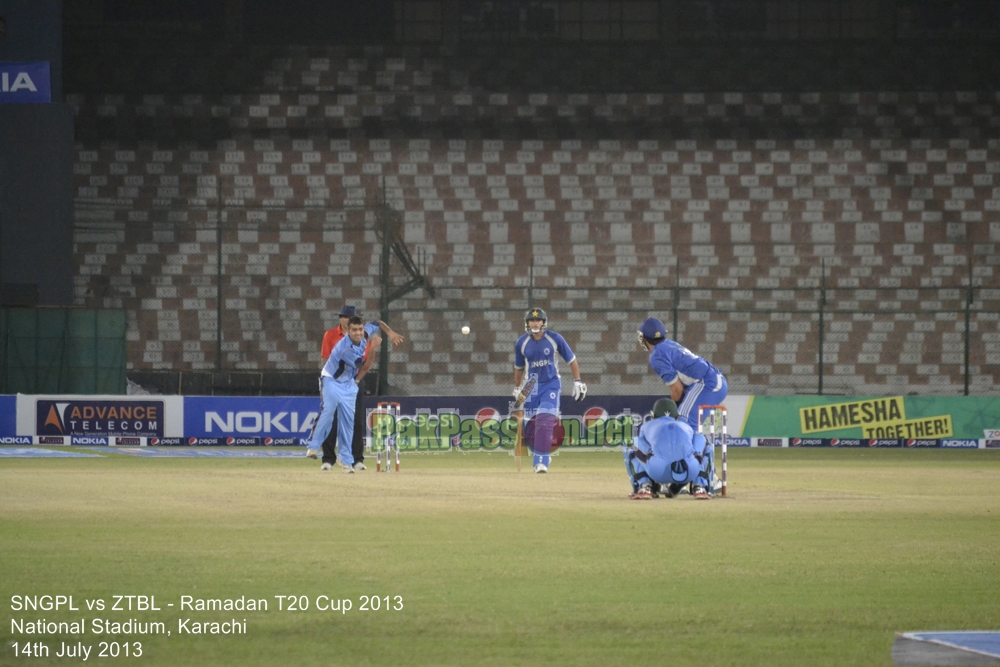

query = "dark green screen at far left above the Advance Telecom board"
[[0, 308, 126, 394]]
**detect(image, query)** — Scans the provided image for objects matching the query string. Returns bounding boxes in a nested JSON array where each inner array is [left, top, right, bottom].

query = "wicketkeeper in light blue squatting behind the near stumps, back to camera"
[[625, 398, 715, 500]]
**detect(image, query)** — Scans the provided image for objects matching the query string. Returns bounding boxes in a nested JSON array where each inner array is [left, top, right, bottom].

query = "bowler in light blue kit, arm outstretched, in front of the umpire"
[[306, 315, 382, 473]]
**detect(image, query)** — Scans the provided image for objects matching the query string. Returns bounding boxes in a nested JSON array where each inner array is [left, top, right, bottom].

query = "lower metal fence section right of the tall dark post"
[[389, 288, 1000, 395]]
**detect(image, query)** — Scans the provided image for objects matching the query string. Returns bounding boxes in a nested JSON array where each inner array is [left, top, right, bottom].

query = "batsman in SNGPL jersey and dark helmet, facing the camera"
[[514, 308, 587, 473]]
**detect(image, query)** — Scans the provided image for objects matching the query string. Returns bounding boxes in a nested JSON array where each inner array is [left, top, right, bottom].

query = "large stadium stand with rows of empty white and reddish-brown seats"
[[68, 47, 1000, 394]]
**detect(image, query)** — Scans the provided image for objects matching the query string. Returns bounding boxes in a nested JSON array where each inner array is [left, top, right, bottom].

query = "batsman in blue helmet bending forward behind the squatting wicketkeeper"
[[639, 317, 729, 431]]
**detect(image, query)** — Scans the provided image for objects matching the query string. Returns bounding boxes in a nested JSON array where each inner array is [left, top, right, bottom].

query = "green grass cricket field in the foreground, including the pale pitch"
[[0, 449, 1000, 667]]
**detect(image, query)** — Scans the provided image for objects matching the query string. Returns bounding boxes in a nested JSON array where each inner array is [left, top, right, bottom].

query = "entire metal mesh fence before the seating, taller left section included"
[[77, 209, 1000, 395]]
